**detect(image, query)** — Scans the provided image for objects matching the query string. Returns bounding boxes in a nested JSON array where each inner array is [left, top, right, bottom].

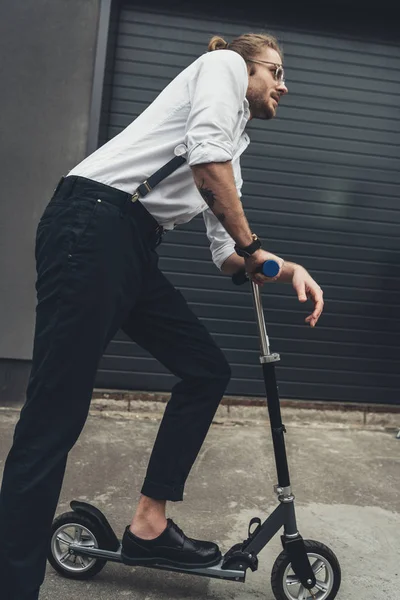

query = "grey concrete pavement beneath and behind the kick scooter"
[[0, 405, 400, 600]]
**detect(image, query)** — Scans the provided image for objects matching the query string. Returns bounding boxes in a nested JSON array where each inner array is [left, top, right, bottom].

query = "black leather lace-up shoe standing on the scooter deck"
[[122, 519, 222, 569]]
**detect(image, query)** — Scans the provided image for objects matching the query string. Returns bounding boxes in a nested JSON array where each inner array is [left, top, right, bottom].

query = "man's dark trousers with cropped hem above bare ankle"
[[0, 177, 230, 600]]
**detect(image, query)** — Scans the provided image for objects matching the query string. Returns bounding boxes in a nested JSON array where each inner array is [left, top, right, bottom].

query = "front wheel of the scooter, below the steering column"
[[271, 540, 341, 600]]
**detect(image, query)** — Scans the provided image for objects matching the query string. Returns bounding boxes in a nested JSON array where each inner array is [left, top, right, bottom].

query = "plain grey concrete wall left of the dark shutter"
[[0, 0, 101, 360]]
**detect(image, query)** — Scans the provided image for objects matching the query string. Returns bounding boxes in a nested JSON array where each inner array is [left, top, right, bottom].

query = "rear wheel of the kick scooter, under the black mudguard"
[[47, 512, 107, 579]]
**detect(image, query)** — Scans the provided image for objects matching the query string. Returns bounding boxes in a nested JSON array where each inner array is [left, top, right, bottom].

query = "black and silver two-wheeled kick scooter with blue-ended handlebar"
[[48, 261, 341, 600]]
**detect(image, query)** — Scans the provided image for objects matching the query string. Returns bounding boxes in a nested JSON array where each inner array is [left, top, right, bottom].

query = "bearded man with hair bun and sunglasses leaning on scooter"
[[0, 34, 323, 600]]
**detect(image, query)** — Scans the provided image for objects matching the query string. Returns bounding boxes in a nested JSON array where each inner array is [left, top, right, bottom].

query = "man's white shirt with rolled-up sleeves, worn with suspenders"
[[68, 50, 250, 268]]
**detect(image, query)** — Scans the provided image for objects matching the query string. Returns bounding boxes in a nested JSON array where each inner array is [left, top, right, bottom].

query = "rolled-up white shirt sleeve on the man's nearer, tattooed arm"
[[185, 50, 248, 166]]
